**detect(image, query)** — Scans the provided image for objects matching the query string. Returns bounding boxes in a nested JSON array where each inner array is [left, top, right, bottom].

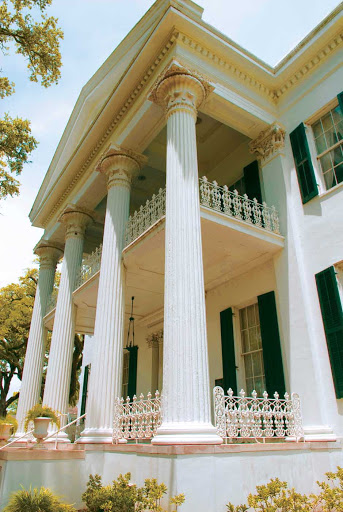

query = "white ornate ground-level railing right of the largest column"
[[213, 386, 304, 441]]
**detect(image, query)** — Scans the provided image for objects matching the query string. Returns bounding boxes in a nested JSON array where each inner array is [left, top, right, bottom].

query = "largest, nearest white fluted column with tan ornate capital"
[[151, 62, 222, 444]]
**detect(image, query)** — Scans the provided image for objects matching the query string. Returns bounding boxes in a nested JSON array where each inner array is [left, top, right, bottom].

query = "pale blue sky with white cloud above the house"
[[0, 0, 339, 287]]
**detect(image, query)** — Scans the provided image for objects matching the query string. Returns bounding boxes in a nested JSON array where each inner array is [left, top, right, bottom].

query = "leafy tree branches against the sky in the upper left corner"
[[0, 0, 63, 199]]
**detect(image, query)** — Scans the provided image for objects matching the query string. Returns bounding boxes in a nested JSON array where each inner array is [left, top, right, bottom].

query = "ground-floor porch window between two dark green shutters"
[[239, 304, 266, 396]]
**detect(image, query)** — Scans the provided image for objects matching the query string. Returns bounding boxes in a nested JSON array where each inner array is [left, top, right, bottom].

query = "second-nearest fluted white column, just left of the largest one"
[[79, 146, 145, 443]]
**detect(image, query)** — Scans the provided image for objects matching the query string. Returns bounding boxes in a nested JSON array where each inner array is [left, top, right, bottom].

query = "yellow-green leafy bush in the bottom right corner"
[[226, 466, 343, 512]]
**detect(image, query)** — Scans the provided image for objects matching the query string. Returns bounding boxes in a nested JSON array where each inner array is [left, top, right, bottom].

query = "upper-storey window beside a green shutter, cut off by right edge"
[[312, 105, 343, 190]]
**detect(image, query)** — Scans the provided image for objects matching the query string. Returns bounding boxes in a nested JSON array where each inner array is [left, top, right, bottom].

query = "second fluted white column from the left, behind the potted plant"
[[43, 207, 92, 440]]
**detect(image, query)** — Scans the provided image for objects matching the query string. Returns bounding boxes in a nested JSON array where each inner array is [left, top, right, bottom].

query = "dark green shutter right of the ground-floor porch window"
[[257, 292, 286, 398]]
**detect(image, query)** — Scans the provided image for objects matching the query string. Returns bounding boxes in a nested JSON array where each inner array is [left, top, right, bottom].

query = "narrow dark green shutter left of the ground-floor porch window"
[[220, 308, 237, 395]]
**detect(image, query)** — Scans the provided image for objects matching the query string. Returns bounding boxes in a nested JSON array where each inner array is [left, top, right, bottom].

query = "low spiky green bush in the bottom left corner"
[[3, 487, 76, 512]]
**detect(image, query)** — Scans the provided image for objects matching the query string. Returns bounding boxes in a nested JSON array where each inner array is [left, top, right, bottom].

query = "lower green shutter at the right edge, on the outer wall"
[[316, 267, 343, 398]]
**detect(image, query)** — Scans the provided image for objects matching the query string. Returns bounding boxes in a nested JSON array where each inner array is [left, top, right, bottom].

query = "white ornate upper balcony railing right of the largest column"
[[200, 176, 280, 234]]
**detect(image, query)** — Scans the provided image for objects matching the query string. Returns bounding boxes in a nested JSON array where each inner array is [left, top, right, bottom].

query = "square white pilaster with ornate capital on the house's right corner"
[[250, 123, 337, 441]]
